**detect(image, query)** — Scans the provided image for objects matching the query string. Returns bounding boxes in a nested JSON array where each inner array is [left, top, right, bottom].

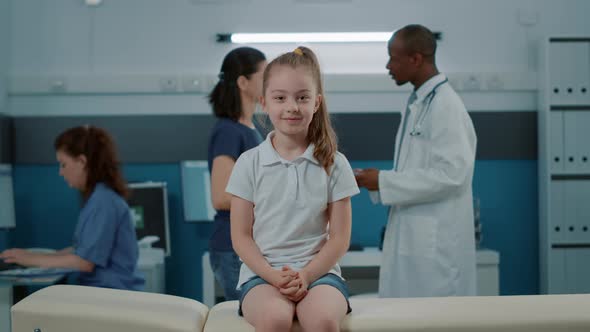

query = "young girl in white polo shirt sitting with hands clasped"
[[227, 47, 359, 331]]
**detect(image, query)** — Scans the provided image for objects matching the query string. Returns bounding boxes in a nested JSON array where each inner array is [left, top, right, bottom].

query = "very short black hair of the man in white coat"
[[394, 24, 436, 63]]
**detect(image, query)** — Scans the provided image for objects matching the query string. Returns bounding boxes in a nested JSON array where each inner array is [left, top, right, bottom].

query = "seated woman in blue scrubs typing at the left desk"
[[0, 126, 145, 290]]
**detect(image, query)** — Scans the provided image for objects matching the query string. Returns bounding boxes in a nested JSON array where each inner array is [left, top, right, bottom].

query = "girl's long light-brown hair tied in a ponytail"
[[263, 46, 338, 174]]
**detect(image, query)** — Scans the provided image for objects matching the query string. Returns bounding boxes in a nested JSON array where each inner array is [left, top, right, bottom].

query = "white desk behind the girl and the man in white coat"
[[201, 247, 500, 307]]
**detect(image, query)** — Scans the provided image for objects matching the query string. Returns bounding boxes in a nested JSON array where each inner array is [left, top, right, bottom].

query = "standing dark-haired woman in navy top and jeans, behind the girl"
[[208, 47, 266, 301]]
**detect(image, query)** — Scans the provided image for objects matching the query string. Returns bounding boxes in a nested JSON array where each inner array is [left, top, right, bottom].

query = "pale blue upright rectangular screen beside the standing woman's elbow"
[[180, 160, 215, 222]]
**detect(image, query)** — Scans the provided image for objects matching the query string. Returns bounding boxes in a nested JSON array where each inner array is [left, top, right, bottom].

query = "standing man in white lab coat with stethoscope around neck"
[[356, 25, 477, 297]]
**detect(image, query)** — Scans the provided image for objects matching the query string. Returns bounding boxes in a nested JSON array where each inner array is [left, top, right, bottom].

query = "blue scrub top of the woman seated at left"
[[73, 183, 145, 290]]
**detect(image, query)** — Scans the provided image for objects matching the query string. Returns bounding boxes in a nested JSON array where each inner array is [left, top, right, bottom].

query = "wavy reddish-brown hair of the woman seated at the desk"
[[53, 126, 129, 200]]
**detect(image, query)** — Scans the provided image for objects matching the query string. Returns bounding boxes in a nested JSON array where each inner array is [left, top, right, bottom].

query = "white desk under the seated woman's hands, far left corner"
[[0, 273, 65, 332]]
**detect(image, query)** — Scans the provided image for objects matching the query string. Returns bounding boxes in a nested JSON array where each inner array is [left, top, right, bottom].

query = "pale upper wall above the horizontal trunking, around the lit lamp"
[[11, 0, 590, 74]]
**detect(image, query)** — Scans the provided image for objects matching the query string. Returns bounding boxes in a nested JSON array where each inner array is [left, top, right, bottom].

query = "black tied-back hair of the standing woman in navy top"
[[209, 47, 266, 121]]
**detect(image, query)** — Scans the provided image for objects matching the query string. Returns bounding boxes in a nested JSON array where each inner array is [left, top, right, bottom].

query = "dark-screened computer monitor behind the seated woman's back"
[[127, 182, 170, 256]]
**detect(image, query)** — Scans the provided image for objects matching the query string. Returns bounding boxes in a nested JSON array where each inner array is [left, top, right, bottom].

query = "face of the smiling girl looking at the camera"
[[261, 65, 322, 137]]
